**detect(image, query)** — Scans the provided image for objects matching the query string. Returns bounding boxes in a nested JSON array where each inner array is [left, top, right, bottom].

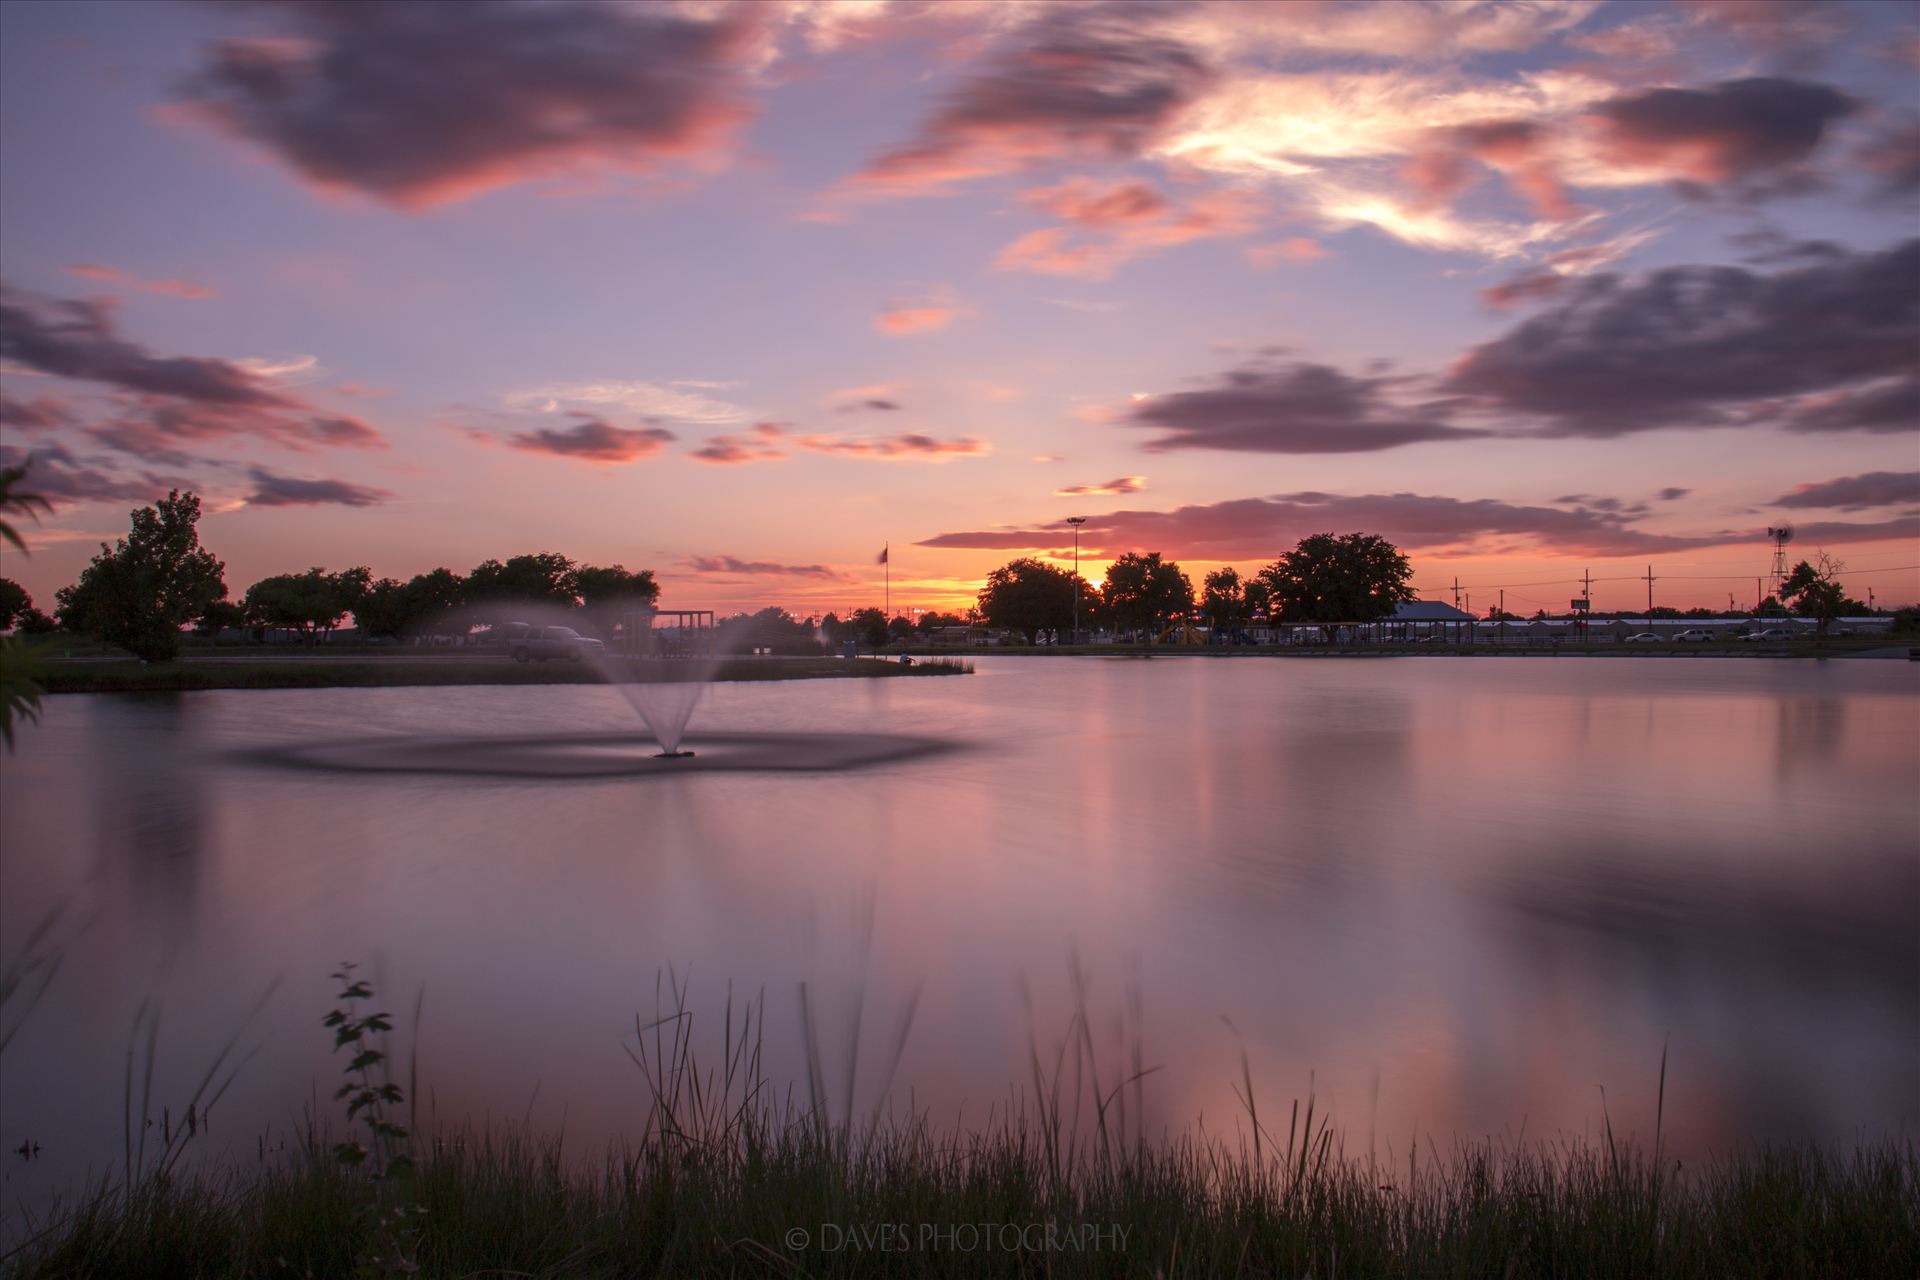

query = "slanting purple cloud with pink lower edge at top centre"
[[858, 6, 1210, 194]]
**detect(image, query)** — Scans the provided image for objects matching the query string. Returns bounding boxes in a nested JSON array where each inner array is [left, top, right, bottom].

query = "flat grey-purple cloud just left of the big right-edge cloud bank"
[[1123, 363, 1488, 453]]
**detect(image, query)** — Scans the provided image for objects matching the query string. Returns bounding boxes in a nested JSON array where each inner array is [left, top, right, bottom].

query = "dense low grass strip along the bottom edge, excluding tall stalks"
[[8, 1125, 1920, 1280]]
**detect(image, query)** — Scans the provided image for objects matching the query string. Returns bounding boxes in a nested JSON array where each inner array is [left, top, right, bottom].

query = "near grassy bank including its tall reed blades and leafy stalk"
[[0, 973, 1920, 1280]]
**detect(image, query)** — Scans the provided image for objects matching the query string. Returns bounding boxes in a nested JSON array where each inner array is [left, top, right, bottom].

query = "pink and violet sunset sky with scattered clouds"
[[0, 0, 1920, 614]]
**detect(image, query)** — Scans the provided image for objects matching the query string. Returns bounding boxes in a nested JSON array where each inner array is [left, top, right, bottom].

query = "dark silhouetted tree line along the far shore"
[[0, 477, 1896, 662]]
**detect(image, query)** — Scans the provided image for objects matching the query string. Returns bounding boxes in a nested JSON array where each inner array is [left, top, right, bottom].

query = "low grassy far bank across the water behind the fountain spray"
[[38, 656, 973, 693]]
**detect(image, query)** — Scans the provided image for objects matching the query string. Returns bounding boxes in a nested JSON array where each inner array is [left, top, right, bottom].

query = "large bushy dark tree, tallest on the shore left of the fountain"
[[56, 489, 227, 662]]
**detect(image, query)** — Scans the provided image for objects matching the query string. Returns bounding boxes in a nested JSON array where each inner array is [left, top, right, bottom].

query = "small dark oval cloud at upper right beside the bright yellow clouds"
[[1594, 77, 1859, 184]]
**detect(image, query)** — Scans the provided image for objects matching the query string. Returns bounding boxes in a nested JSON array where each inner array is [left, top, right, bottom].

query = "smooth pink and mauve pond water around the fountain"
[[0, 658, 1920, 1197]]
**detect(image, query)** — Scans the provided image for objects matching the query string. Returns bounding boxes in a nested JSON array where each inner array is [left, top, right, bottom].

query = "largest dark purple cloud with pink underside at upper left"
[[180, 0, 760, 205]]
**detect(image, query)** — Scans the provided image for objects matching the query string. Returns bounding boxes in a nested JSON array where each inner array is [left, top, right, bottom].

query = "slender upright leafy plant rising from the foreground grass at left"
[[321, 961, 426, 1276]]
